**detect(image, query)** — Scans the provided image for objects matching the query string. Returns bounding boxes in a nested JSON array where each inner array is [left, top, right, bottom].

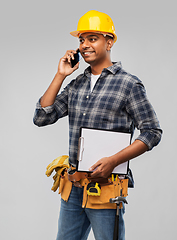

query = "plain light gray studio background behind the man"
[[0, 0, 177, 240]]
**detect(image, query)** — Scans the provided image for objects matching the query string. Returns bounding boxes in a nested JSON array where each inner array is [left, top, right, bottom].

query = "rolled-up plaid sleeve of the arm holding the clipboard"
[[127, 82, 162, 150]]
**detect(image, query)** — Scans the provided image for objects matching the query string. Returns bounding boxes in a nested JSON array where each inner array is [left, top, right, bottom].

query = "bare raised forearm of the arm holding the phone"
[[40, 73, 65, 107]]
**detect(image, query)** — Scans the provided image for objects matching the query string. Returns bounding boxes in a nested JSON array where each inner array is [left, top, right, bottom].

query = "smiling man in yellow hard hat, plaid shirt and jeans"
[[34, 10, 162, 240]]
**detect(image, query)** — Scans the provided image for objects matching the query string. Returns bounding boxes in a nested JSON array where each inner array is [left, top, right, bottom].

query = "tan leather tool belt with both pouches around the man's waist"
[[45, 157, 128, 209]]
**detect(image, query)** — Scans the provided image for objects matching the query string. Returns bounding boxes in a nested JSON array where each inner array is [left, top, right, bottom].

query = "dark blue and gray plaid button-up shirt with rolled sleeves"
[[34, 62, 162, 166]]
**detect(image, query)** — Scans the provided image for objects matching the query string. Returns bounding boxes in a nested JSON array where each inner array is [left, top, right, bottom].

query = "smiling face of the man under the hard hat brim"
[[79, 32, 108, 66]]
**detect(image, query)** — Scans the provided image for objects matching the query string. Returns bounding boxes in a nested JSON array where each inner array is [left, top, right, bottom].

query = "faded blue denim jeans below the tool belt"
[[56, 186, 125, 240]]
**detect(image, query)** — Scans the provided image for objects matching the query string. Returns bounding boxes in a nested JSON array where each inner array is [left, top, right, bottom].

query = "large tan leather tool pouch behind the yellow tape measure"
[[82, 178, 128, 209]]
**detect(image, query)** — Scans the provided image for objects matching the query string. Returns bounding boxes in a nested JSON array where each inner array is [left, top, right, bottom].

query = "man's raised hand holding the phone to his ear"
[[58, 50, 79, 78]]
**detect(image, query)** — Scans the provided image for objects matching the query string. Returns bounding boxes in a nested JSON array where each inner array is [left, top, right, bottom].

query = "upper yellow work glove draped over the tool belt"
[[45, 155, 69, 177]]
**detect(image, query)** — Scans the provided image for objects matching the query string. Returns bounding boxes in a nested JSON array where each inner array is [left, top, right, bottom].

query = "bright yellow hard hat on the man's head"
[[70, 10, 117, 42]]
